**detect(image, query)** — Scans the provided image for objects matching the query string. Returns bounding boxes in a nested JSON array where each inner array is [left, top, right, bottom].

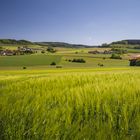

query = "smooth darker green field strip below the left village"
[[0, 55, 61, 67]]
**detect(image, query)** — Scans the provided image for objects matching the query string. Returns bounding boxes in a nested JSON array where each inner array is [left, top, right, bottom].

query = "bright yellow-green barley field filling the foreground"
[[0, 68, 140, 140]]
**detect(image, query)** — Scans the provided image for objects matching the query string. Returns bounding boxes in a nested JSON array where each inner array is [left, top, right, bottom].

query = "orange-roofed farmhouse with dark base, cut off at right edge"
[[129, 55, 140, 66]]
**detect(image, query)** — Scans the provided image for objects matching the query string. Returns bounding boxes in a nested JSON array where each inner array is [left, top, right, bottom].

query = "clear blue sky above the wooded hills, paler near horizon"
[[0, 0, 140, 45]]
